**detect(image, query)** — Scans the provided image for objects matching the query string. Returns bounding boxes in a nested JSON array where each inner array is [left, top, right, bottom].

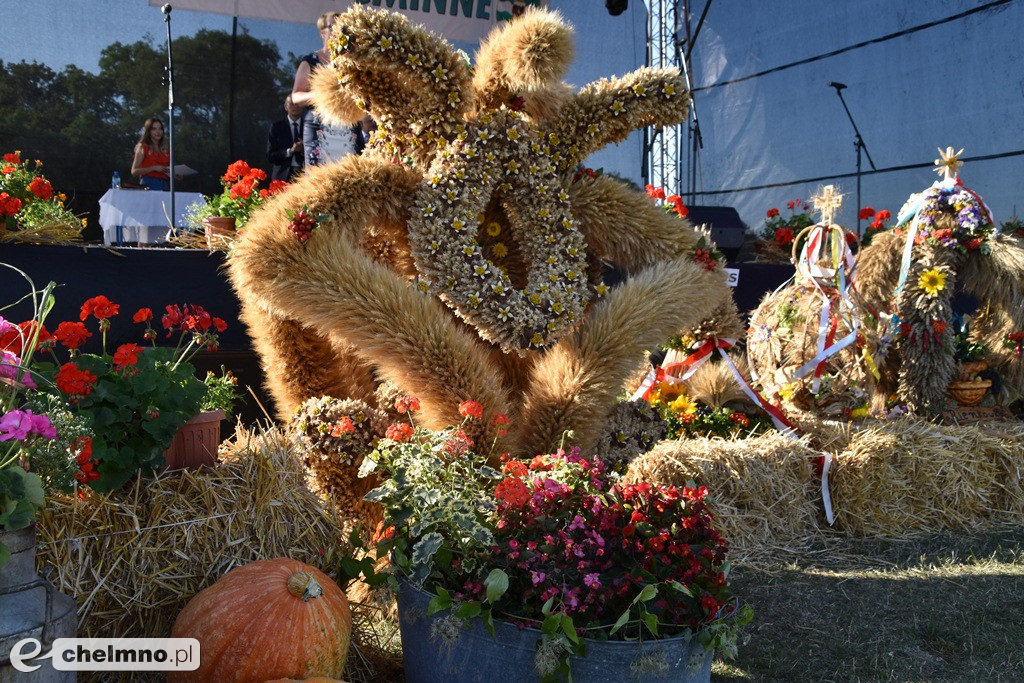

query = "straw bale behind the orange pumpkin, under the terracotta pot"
[[38, 429, 373, 680]]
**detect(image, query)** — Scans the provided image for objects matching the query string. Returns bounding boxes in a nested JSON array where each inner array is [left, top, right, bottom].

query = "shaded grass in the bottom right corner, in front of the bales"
[[713, 528, 1024, 682]]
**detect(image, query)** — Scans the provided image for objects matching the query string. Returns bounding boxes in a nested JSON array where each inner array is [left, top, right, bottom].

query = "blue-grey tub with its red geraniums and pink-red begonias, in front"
[[343, 399, 751, 682]]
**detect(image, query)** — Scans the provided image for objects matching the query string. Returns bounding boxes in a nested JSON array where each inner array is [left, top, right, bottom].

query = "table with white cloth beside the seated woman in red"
[[99, 189, 205, 245]]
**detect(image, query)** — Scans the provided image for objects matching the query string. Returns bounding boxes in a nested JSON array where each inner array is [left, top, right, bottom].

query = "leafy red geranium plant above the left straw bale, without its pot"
[[18, 296, 232, 490]]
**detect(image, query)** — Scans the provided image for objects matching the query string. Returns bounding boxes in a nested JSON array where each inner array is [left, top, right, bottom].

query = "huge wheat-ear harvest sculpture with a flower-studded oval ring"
[[229, 6, 740, 455]]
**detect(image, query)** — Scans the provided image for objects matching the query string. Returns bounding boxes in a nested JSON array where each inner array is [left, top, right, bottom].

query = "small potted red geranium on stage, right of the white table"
[[186, 160, 288, 249]]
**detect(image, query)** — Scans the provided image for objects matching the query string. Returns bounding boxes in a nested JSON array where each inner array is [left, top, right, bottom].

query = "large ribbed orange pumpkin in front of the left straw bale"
[[167, 558, 352, 683]]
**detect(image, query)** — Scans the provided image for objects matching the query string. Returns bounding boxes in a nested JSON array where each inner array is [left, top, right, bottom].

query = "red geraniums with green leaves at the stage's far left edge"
[[0, 151, 85, 242]]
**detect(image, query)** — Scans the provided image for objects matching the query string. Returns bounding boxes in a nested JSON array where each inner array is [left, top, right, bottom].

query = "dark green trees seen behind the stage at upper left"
[[0, 29, 295, 232]]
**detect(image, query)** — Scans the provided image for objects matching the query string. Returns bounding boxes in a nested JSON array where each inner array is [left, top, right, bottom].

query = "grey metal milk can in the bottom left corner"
[[0, 525, 78, 683]]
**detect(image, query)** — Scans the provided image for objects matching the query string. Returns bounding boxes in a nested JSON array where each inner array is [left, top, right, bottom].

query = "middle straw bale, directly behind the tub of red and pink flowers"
[[626, 432, 822, 562]]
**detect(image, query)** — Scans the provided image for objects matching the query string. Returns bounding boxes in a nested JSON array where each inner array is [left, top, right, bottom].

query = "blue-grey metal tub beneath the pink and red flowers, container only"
[[398, 585, 713, 683]]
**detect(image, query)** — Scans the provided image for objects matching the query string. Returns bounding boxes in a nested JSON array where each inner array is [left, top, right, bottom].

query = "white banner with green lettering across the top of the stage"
[[150, 0, 548, 43]]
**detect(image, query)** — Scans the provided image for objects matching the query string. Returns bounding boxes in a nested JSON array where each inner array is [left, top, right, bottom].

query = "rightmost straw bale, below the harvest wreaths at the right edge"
[[831, 418, 1024, 537]]
